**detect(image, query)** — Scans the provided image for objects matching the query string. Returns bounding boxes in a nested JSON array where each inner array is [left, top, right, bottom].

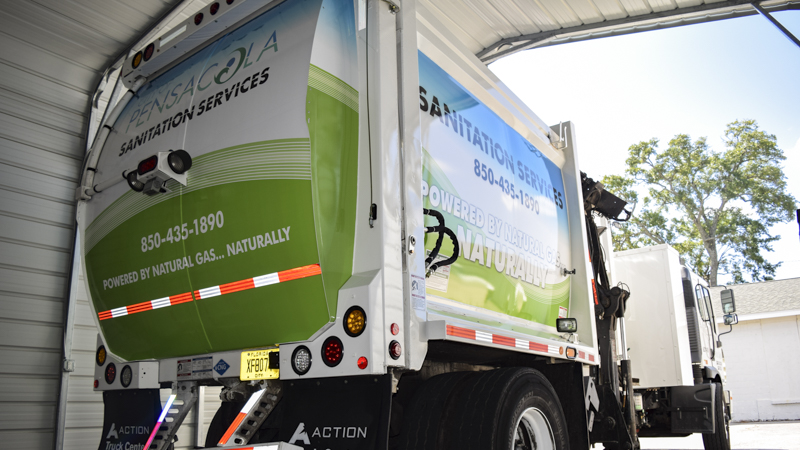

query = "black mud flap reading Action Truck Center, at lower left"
[[97, 389, 161, 450]]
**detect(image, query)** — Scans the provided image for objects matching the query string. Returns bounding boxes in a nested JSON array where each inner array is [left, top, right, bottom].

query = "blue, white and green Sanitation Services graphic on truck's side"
[[419, 52, 571, 326]]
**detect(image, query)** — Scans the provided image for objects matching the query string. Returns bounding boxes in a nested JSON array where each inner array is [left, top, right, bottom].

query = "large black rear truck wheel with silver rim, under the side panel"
[[443, 368, 569, 450]]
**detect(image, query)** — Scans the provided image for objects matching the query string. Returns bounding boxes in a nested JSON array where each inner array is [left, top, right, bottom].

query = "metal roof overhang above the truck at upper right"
[[420, 0, 800, 64]]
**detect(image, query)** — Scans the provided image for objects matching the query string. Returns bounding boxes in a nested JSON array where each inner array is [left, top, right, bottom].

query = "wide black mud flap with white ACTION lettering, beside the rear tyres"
[[278, 375, 392, 450]]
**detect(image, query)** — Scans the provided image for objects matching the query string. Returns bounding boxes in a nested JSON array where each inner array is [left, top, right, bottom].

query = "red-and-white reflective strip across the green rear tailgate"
[[97, 264, 322, 320]]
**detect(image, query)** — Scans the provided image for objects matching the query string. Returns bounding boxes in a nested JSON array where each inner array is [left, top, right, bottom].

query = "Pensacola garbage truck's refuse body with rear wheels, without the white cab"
[[76, 0, 727, 450]]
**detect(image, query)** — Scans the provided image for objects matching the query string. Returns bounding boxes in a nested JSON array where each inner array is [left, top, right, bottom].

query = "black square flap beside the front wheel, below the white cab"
[[670, 384, 714, 433]]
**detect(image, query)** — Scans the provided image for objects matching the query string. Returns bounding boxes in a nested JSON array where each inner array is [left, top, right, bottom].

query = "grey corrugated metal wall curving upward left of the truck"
[[0, 0, 177, 449]]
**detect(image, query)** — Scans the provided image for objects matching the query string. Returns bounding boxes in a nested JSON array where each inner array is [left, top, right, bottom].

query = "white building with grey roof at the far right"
[[711, 278, 800, 422]]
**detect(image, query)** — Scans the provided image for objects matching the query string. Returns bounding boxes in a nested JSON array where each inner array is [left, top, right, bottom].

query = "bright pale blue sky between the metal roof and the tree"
[[490, 11, 800, 282]]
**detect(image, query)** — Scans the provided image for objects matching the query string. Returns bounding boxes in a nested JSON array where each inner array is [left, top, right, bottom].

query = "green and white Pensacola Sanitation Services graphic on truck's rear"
[[81, 0, 358, 359]]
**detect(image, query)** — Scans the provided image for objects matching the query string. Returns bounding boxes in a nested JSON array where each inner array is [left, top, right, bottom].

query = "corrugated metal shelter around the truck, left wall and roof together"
[[0, 0, 800, 449]]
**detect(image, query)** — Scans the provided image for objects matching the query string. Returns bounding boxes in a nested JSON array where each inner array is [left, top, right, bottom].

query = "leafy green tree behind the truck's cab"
[[603, 120, 796, 286]]
